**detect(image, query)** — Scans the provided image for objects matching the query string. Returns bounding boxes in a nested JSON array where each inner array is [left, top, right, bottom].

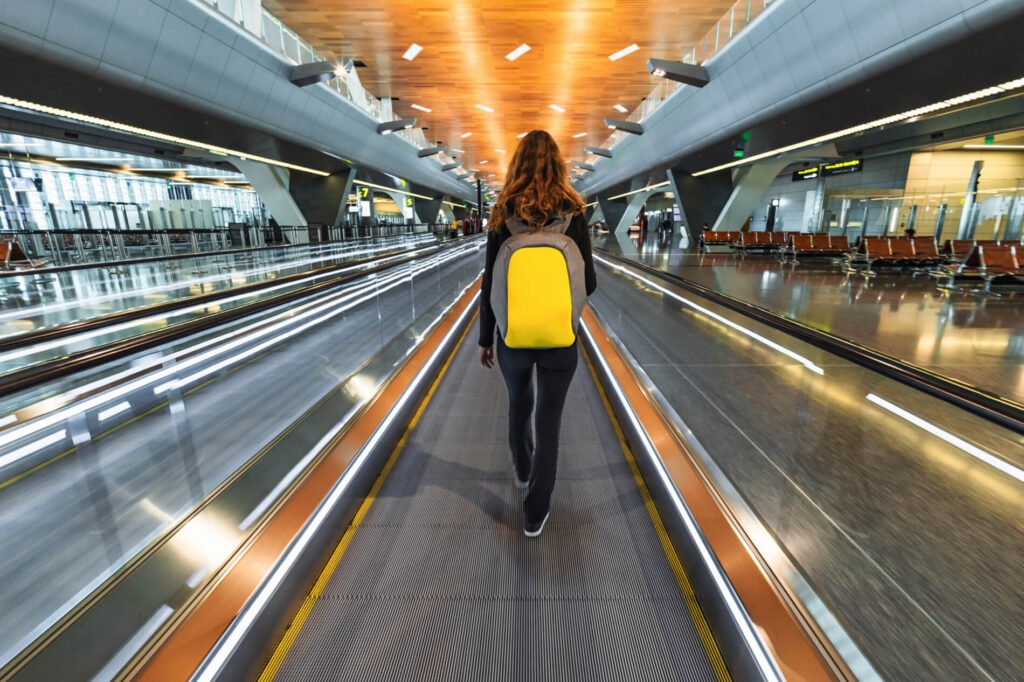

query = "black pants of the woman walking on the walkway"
[[498, 334, 580, 523]]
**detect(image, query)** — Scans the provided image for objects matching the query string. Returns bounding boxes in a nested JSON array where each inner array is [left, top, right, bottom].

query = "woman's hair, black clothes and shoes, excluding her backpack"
[[479, 130, 597, 538]]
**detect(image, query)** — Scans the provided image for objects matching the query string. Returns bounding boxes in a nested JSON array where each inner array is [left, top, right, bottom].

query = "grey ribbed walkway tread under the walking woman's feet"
[[263, 327, 728, 680]]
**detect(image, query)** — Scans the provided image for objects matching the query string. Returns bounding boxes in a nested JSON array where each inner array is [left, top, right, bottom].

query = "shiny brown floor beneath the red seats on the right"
[[593, 228, 1024, 403]]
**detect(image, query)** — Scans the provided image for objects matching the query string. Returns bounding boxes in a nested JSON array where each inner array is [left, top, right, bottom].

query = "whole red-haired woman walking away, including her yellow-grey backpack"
[[480, 130, 596, 538]]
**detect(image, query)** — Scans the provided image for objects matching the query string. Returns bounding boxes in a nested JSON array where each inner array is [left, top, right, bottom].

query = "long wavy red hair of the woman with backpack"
[[487, 130, 584, 230]]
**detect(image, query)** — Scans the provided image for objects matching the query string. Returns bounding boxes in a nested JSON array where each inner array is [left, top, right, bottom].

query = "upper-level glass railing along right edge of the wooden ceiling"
[[587, 0, 779, 157]]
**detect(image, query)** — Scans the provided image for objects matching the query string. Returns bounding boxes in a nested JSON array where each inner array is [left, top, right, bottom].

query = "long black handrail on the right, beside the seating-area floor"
[[595, 248, 1024, 434]]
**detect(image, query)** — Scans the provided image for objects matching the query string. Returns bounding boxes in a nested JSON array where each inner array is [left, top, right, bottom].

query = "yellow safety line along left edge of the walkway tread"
[[259, 312, 476, 682]]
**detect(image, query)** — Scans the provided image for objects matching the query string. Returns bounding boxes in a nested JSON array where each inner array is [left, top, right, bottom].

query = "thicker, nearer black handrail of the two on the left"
[[0, 240, 479, 397]]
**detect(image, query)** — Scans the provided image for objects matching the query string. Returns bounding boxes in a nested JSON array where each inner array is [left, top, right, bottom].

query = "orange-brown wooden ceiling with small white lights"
[[263, 0, 745, 184]]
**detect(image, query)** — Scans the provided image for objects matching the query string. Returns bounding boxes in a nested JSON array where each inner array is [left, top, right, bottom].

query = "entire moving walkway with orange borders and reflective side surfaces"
[[0, 235, 1024, 681]]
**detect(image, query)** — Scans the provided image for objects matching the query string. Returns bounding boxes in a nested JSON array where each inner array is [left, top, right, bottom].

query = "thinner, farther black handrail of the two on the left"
[[0, 235, 468, 351]]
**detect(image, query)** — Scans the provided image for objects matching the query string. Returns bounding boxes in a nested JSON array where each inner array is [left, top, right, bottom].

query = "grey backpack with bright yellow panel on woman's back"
[[490, 215, 587, 348]]
